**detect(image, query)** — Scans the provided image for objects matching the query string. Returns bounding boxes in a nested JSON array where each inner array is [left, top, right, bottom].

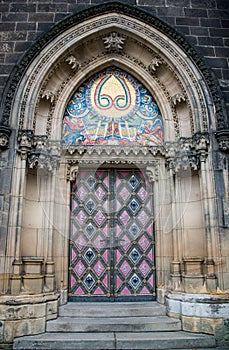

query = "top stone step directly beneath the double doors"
[[59, 302, 166, 317]]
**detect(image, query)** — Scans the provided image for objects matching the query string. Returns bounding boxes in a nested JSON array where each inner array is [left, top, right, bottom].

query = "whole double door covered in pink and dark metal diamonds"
[[69, 169, 155, 301]]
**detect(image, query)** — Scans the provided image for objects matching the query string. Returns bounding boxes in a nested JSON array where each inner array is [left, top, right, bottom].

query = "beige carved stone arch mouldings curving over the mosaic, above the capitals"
[[12, 13, 215, 141]]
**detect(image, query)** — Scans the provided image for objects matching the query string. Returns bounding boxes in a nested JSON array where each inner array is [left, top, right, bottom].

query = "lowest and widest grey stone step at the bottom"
[[13, 332, 215, 350]]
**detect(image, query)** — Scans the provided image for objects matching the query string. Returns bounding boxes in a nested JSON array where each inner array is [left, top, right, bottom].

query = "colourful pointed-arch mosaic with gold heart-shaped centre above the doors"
[[63, 68, 164, 146]]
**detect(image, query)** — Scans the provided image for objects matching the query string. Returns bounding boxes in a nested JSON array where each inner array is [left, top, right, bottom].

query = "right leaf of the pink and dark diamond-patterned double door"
[[113, 170, 155, 300]]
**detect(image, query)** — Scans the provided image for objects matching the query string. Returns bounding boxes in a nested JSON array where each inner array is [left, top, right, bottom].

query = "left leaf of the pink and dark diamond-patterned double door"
[[70, 171, 111, 298]]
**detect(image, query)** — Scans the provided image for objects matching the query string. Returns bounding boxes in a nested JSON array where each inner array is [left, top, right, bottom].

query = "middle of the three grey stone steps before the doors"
[[46, 316, 181, 333]]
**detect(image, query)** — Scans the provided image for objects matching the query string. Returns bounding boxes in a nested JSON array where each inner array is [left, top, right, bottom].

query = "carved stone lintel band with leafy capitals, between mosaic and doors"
[[18, 130, 209, 175]]
